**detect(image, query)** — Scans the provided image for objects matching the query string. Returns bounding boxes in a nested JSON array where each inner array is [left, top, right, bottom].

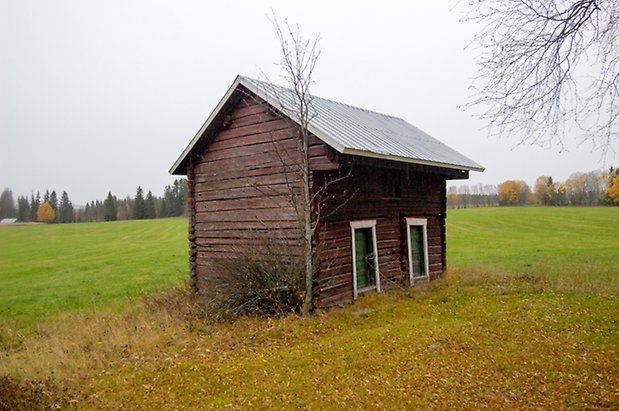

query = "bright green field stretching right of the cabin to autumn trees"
[[447, 207, 619, 295]]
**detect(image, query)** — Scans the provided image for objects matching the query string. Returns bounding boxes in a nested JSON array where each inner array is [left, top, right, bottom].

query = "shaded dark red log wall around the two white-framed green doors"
[[316, 161, 445, 306]]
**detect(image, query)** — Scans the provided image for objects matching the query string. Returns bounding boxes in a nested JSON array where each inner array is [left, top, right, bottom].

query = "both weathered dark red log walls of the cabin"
[[187, 91, 445, 306]]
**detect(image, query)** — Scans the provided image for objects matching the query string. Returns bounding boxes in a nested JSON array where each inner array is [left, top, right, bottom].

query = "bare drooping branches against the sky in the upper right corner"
[[464, 0, 619, 157]]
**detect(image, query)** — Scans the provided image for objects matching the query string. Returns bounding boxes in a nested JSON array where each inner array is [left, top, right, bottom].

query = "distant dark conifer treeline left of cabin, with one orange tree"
[[0, 179, 187, 223]]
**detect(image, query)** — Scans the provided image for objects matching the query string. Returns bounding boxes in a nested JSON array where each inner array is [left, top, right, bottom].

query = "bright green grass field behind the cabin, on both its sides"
[[0, 207, 619, 328]]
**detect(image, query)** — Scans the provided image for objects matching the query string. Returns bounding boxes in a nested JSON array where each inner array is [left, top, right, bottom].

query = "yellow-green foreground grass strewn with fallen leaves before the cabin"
[[80, 276, 619, 409]]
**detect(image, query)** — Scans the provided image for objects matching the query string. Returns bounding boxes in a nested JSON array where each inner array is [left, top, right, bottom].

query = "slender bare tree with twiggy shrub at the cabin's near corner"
[[207, 13, 355, 316]]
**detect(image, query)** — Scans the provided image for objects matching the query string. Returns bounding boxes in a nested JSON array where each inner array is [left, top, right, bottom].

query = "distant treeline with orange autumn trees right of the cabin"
[[447, 167, 619, 208]]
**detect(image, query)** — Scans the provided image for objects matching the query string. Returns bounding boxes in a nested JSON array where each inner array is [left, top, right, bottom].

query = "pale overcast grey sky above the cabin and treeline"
[[0, 0, 617, 204]]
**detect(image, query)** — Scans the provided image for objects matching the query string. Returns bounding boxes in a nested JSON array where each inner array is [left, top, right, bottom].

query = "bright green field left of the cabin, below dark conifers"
[[0, 218, 188, 328]]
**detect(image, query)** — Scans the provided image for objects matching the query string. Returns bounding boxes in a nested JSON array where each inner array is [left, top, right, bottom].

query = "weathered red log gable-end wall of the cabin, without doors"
[[187, 96, 338, 291]]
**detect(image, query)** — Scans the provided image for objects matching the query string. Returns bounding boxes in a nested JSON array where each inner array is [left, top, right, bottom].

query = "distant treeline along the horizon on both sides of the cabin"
[[0, 167, 619, 223]]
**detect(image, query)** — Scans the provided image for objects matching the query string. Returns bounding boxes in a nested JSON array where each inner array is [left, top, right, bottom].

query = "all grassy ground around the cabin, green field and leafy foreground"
[[0, 207, 619, 409]]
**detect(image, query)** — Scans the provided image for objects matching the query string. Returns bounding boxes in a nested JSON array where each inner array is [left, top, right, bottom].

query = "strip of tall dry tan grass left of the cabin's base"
[[0, 286, 200, 388]]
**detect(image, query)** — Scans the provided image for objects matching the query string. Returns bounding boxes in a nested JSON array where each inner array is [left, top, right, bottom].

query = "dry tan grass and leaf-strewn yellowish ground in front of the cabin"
[[0, 270, 619, 409]]
